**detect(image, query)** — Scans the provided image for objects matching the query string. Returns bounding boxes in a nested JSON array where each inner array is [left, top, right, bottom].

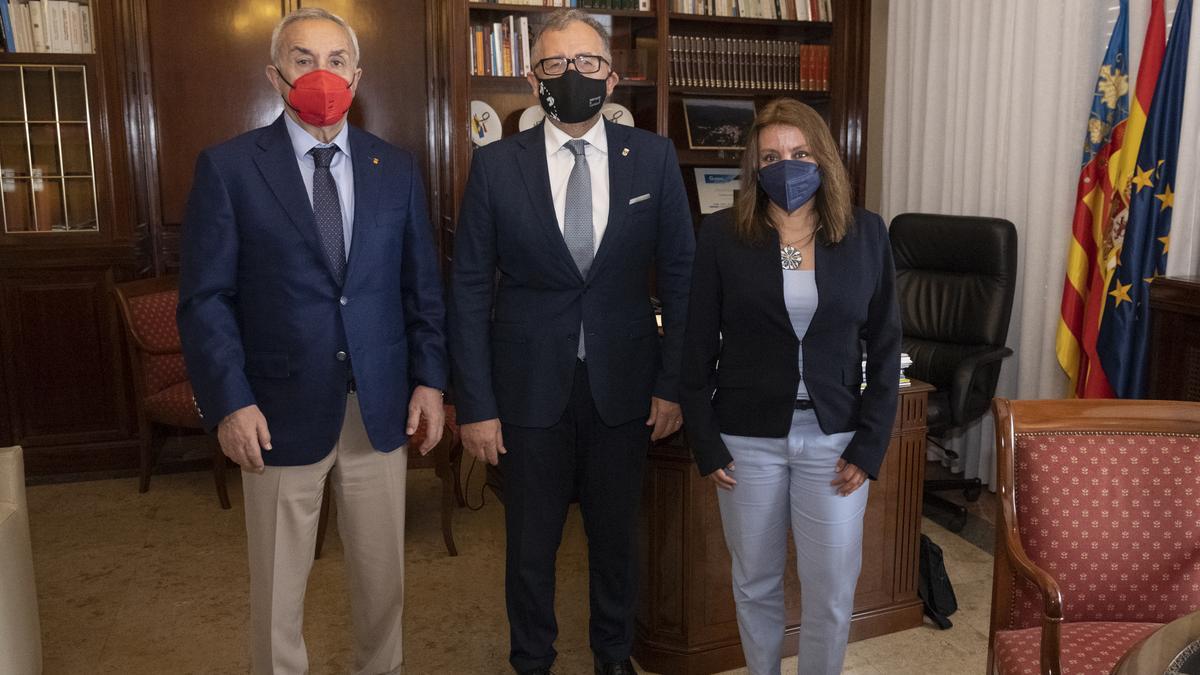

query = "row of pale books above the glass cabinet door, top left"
[[0, 0, 94, 54]]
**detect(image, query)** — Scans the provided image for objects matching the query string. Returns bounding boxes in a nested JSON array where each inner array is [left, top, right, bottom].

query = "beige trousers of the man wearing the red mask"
[[241, 394, 408, 675]]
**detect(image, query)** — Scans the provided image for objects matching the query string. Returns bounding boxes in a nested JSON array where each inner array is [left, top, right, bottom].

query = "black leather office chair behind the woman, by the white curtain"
[[890, 214, 1016, 532]]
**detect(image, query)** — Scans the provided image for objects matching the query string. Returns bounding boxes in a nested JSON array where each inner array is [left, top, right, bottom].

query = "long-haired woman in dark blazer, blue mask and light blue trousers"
[[680, 98, 900, 675]]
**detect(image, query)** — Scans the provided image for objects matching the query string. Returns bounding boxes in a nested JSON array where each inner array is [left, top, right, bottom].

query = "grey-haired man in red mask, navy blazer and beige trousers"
[[179, 8, 448, 674]]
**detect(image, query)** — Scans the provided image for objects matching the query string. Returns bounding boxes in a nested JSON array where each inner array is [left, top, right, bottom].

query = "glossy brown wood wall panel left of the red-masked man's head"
[[142, 0, 283, 226]]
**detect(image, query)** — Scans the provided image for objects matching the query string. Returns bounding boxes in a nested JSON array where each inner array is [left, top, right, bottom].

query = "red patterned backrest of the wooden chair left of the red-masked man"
[[115, 276, 187, 396]]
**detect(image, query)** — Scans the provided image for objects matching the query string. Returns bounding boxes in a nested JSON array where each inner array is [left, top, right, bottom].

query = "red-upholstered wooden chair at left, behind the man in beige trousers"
[[115, 276, 229, 508]]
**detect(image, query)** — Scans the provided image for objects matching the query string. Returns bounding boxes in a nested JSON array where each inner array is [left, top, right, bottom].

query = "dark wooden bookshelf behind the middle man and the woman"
[[439, 0, 870, 248]]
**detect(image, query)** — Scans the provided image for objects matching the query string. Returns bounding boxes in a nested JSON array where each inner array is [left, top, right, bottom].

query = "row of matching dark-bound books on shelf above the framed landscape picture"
[[668, 35, 829, 91]]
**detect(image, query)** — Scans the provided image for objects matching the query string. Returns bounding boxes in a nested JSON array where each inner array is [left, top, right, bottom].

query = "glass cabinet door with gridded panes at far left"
[[0, 65, 98, 233]]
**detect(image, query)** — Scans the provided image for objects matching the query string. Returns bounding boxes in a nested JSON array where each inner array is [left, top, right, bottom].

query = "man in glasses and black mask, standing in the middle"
[[450, 10, 695, 674]]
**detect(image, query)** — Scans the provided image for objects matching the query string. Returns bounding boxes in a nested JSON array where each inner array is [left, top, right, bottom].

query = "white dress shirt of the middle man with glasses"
[[541, 119, 608, 252]]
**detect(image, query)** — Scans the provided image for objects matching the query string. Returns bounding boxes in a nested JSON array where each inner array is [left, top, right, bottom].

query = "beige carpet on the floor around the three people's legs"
[[29, 461, 991, 675]]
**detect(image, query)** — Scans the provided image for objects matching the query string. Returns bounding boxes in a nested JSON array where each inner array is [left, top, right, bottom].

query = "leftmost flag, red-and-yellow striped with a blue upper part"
[[1055, 0, 1129, 396]]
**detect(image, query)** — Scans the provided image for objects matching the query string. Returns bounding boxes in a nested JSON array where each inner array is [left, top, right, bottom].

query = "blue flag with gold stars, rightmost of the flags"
[[1096, 0, 1192, 399]]
